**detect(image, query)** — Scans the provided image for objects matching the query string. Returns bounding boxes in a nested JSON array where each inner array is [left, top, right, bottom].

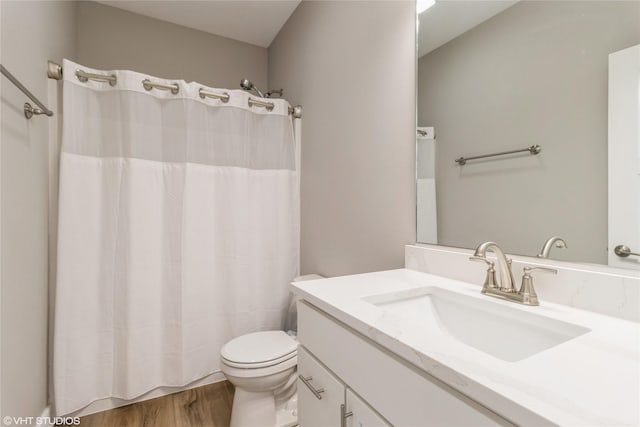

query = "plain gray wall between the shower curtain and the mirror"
[[269, 1, 415, 276]]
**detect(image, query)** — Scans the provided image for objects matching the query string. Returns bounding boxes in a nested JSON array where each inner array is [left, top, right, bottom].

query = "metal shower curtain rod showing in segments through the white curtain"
[[47, 61, 302, 119]]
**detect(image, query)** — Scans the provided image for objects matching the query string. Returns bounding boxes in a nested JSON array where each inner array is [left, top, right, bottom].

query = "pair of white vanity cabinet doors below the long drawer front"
[[298, 347, 389, 427]]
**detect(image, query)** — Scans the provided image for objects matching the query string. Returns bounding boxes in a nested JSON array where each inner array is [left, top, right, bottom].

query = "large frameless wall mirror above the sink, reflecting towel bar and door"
[[416, 0, 640, 269]]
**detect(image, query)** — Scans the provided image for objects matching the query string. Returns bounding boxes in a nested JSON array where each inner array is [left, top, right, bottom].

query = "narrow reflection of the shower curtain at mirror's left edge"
[[416, 127, 438, 244]]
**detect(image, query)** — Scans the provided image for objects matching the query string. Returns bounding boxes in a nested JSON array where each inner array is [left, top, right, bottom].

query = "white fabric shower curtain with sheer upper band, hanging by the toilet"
[[54, 60, 299, 415]]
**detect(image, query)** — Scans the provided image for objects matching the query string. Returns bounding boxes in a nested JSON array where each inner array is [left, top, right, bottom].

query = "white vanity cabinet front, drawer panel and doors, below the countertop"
[[298, 300, 513, 427]]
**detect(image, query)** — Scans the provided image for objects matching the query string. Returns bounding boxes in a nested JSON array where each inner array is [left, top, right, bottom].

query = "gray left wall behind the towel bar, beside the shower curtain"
[[0, 1, 75, 417]]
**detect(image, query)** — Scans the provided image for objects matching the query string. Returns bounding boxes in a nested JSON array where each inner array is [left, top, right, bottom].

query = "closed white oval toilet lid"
[[220, 331, 298, 366]]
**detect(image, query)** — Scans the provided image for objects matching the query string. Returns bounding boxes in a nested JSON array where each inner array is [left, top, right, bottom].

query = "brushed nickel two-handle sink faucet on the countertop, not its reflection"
[[469, 242, 558, 305]]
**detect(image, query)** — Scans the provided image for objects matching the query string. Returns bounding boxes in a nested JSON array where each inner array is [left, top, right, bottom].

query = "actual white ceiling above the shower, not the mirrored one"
[[98, 0, 300, 47]]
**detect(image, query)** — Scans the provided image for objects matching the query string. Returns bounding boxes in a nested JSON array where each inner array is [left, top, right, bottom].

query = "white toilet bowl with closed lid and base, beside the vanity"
[[220, 331, 298, 427]]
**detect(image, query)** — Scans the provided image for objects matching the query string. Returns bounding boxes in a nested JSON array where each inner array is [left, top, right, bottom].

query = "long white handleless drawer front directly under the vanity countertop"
[[298, 301, 513, 427]]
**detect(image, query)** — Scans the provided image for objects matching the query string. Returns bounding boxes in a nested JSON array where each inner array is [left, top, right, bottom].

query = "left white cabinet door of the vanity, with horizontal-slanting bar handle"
[[298, 346, 345, 427]]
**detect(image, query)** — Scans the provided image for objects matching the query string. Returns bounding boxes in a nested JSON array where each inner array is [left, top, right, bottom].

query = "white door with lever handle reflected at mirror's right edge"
[[608, 45, 640, 270]]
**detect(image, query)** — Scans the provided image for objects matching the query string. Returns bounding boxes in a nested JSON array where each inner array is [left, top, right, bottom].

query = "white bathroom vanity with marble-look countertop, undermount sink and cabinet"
[[292, 269, 640, 427]]
